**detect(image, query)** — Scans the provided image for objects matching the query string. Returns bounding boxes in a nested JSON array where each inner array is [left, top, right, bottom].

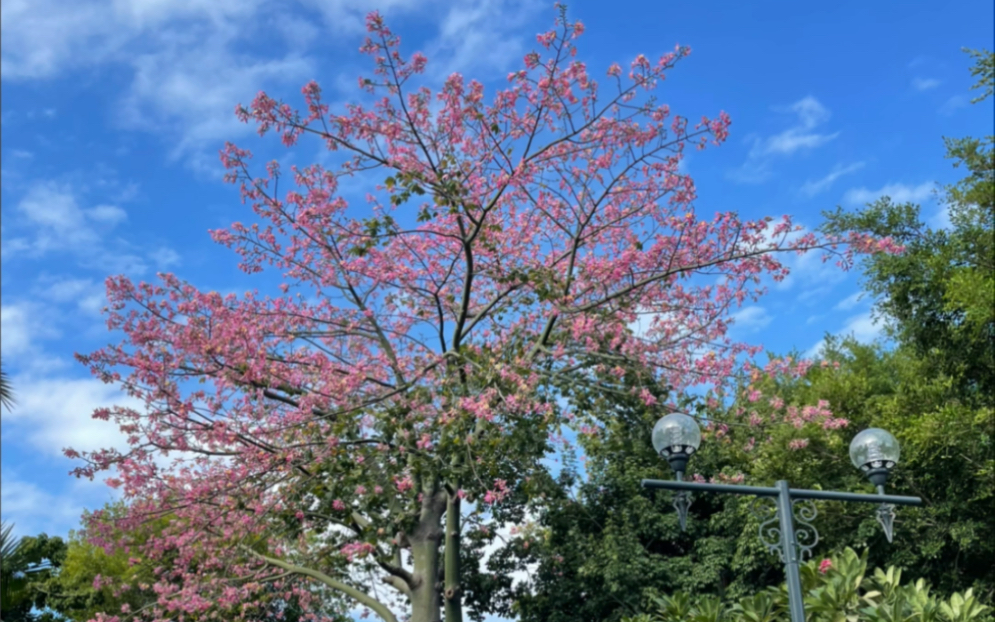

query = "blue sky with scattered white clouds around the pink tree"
[[0, 0, 995, 620]]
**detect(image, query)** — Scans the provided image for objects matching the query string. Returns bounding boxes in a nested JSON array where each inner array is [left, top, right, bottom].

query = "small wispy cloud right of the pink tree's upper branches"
[[729, 96, 839, 183]]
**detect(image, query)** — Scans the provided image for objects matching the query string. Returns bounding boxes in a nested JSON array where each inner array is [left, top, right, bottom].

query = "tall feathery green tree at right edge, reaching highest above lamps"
[[823, 51, 995, 405]]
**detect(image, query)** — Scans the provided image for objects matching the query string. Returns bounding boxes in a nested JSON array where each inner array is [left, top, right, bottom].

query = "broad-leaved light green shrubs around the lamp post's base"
[[623, 548, 992, 622]]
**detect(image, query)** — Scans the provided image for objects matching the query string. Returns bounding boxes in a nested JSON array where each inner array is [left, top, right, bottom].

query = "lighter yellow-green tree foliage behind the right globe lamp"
[[749, 339, 995, 602]]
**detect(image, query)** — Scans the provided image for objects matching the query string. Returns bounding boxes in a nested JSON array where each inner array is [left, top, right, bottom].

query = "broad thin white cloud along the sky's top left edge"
[[2, 0, 552, 176]]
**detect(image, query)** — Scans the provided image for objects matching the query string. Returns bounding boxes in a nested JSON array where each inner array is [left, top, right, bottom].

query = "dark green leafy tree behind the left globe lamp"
[[482, 370, 778, 622]]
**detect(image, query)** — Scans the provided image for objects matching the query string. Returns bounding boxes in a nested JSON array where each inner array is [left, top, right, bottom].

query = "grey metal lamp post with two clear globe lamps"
[[642, 413, 922, 622]]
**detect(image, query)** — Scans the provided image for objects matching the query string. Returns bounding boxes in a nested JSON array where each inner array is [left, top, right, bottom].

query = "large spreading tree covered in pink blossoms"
[[67, 4, 889, 622]]
